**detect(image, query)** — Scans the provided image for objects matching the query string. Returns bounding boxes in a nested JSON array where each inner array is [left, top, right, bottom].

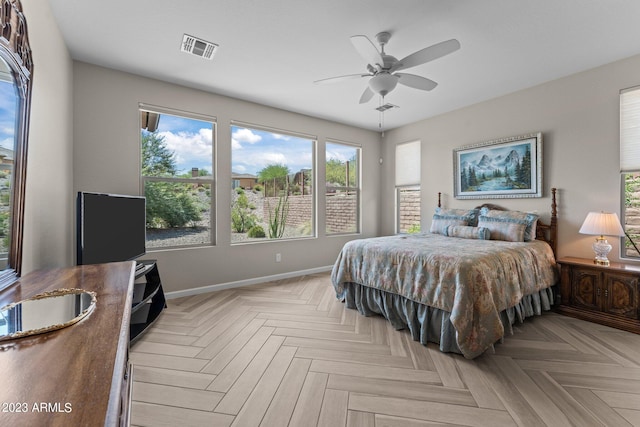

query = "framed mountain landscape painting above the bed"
[[453, 132, 542, 199]]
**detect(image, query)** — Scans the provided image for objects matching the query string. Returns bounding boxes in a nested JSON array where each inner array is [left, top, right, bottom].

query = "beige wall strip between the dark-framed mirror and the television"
[[22, 0, 75, 273]]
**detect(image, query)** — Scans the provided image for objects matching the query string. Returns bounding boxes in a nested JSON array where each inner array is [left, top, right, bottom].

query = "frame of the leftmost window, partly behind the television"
[[138, 103, 218, 253]]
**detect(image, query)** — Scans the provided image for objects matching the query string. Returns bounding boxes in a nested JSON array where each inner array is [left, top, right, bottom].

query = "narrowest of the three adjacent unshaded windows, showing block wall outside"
[[325, 142, 360, 235]]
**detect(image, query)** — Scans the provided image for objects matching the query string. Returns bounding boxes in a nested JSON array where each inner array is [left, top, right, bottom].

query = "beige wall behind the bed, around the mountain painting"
[[381, 51, 640, 259]]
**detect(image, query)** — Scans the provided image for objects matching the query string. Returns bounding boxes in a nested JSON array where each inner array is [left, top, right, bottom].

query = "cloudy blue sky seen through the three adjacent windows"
[[147, 114, 356, 175]]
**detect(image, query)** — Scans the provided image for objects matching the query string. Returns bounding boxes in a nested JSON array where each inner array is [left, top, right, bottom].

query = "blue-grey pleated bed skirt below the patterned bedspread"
[[337, 283, 553, 354]]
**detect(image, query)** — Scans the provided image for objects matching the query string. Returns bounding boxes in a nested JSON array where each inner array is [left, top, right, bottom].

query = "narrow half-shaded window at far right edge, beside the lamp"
[[620, 87, 640, 259]]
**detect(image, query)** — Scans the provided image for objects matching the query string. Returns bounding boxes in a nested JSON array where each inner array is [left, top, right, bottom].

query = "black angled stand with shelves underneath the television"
[[129, 260, 167, 344]]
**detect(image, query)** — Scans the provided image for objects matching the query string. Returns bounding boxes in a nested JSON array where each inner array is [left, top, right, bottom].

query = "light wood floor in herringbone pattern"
[[131, 273, 640, 427]]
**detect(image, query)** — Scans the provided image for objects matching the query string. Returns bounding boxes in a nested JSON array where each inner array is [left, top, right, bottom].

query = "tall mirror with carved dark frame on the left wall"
[[0, 0, 33, 290]]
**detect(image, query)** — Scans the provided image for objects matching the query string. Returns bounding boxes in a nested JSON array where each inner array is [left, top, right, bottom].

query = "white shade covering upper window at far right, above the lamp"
[[620, 87, 640, 172]]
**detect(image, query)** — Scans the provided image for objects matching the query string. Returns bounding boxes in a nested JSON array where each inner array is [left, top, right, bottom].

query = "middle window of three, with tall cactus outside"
[[231, 123, 316, 243]]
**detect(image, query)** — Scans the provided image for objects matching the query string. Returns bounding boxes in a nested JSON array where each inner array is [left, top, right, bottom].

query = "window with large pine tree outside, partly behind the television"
[[140, 106, 215, 249]]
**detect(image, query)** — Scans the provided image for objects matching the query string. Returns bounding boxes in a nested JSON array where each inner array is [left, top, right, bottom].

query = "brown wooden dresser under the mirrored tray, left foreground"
[[0, 262, 135, 427]]
